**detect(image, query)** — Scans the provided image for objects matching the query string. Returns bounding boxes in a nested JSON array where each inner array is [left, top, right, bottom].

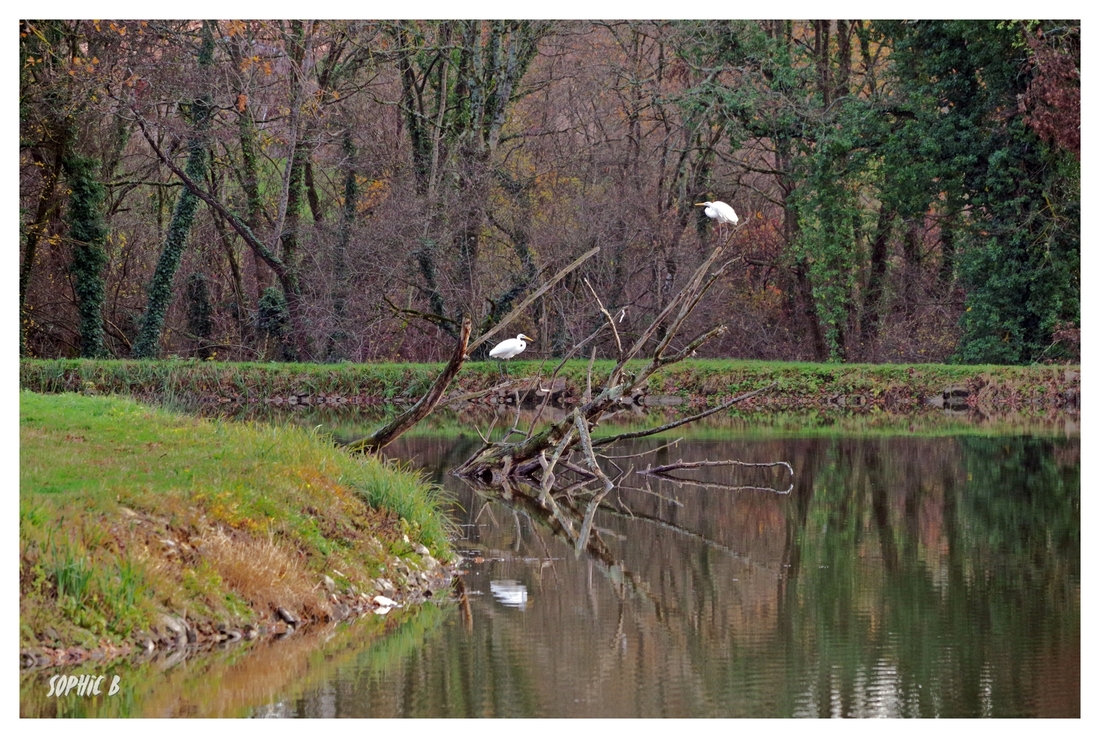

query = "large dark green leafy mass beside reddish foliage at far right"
[[891, 21, 1080, 364]]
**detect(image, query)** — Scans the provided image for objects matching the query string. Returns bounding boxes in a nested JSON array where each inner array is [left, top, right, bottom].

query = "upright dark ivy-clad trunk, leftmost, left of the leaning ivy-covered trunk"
[[63, 154, 107, 359]]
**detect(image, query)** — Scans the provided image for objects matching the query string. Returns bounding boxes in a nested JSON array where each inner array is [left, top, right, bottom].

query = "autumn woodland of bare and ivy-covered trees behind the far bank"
[[19, 20, 1081, 364]]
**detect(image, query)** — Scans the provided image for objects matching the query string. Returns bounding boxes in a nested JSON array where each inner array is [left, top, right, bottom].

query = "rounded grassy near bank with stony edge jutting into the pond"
[[19, 392, 451, 649]]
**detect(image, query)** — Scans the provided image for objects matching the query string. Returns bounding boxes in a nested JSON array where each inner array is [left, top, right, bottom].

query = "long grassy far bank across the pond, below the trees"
[[20, 359, 1080, 414]]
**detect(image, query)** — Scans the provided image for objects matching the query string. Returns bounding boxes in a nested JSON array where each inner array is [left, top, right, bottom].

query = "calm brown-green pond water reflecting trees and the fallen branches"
[[23, 417, 1080, 717]]
